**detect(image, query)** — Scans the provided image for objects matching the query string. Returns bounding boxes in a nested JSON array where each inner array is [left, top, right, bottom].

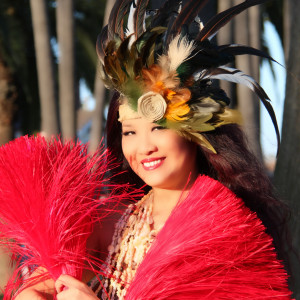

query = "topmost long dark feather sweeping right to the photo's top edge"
[[196, 0, 268, 41]]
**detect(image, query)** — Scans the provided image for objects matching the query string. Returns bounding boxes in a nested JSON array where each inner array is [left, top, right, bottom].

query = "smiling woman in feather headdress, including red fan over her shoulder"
[[17, 0, 290, 300]]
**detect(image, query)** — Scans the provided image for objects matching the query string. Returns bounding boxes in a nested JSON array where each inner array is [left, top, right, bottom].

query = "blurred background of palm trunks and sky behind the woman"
[[0, 0, 300, 299]]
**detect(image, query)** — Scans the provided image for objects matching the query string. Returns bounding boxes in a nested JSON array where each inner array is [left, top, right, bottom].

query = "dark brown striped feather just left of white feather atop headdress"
[[108, 0, 132, 40]]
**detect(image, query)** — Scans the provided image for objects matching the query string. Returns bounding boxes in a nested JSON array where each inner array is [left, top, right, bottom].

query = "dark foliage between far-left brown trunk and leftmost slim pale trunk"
[[0, 0, 39, 133]]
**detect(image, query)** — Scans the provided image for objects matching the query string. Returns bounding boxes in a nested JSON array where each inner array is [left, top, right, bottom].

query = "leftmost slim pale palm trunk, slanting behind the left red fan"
[[30, 0, 58, 136]]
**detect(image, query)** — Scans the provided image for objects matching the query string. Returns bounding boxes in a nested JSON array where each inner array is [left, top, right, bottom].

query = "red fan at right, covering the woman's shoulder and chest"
[[126, 176, 291, 300]]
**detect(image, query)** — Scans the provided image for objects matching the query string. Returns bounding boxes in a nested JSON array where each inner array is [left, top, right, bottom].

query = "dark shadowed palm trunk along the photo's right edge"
[[274, 0, 300, 299]]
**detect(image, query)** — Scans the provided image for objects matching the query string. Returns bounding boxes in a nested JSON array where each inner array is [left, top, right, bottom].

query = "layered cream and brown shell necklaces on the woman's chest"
[[96, 191, 158, 300]]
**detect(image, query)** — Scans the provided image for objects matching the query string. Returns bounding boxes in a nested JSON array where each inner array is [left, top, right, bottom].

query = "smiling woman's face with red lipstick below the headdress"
[[122, 118, 197, 190]]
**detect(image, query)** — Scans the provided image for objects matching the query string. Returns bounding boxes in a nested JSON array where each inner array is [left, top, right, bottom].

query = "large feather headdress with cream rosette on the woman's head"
[[96, 0, 280, 152]]
